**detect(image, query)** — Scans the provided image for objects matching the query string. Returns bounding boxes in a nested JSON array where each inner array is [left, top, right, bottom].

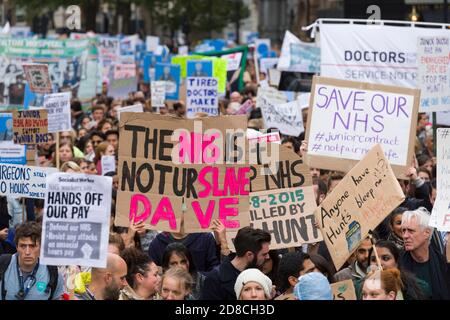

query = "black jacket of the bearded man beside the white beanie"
[[200, 257, 241, 300]]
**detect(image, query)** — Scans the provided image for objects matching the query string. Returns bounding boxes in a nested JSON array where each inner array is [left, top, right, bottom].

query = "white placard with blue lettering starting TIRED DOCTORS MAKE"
[[186, 77, 219, 118]]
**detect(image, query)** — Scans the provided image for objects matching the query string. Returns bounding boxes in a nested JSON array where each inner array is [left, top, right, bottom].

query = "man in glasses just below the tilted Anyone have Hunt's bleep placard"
[[334, 238, 372, 282]]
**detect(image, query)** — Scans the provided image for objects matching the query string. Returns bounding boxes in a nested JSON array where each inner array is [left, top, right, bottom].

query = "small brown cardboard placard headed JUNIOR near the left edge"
[[13, 109, 48, 144]]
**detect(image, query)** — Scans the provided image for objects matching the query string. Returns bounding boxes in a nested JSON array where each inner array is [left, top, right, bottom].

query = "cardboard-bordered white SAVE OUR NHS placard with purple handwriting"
[[306, 77, 420, 178]]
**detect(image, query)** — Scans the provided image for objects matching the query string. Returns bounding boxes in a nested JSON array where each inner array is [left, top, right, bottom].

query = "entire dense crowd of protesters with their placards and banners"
[[0, 17, 450, 301]]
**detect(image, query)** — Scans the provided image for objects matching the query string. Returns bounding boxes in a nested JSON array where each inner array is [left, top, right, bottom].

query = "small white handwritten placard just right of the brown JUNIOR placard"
[[44, 92, 72, 133]]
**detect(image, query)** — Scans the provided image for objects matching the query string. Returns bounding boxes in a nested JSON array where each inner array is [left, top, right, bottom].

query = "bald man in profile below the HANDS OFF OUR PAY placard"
[[76, 253, 127, 300]]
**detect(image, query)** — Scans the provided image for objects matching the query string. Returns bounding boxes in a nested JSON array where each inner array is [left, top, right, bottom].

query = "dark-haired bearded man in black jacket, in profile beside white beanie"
[[200, 227, 271, 300]]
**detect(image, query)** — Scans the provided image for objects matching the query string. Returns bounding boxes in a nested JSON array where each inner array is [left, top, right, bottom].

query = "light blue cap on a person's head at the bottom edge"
[[294, 272, 333, 300]]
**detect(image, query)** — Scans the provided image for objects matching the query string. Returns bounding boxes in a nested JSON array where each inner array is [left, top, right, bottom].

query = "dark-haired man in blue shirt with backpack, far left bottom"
[[0, 221, 64, 300]]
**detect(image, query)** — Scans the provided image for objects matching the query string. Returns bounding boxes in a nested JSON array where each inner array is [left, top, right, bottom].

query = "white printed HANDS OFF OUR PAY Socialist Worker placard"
[[40, 172, 112, 268]]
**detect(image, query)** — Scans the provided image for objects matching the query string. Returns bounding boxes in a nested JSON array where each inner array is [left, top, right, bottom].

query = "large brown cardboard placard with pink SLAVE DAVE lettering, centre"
[[115, 113, 250, 232]]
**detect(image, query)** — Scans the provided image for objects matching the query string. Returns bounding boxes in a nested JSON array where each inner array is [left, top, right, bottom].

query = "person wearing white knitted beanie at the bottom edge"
[[234, 268, 272, 300]]
